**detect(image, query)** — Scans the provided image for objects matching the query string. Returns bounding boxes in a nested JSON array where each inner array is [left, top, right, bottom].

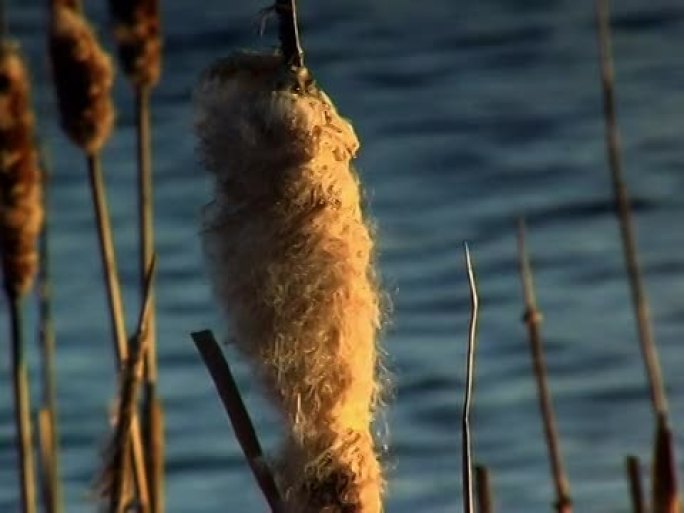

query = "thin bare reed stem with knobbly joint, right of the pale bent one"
[[518, 219, 572, 513]]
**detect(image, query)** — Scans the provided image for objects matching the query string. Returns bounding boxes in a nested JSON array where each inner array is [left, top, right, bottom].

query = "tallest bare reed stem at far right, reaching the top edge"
[[596, 0, 667, 414]]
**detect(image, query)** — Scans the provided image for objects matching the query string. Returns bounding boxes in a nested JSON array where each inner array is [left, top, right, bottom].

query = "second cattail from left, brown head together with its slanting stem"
[[50, 4, 149, 511]]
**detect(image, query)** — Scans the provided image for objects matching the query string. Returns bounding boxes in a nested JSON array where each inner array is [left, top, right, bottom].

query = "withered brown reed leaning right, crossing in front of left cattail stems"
[[109, 257, 154, 513]]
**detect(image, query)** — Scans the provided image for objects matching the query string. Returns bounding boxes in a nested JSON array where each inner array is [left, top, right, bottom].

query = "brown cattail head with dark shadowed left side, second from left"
[[50, 3, 114, 154]]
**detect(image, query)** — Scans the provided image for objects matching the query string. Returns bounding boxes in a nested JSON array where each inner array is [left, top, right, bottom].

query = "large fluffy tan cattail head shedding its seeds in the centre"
[[195, 54, 382, 513]]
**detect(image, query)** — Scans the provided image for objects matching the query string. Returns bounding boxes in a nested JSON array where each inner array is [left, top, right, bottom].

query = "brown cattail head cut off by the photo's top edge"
[[109, 0, 162, 87]]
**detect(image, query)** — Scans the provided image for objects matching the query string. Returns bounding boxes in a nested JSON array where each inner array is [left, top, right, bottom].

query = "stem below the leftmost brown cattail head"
[[7, 288, 36, 513]]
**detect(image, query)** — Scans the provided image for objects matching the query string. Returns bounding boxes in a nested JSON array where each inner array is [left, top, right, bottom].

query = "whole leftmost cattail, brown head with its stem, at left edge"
[[0, 38, 43, 513]]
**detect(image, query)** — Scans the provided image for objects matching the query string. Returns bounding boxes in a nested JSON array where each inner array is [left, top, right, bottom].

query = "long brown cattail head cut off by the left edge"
[[0, 42, 43, 296]]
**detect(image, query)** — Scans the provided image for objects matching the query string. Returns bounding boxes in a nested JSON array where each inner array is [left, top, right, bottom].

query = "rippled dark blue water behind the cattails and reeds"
[[0, 0, 684, 513]]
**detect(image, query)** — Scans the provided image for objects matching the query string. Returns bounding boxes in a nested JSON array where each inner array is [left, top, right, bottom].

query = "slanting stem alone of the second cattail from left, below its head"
[[87, 151, 149, 511]]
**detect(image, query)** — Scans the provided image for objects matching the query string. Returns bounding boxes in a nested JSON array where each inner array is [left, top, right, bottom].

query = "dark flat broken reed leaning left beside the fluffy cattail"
[[192, 330, 283, 513]]
